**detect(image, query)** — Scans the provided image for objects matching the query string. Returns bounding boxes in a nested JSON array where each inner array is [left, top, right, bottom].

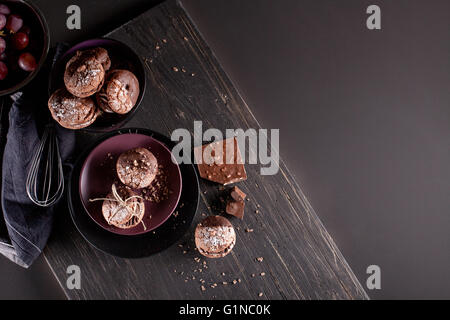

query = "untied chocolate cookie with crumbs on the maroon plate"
[[116, 148, 158, 189]]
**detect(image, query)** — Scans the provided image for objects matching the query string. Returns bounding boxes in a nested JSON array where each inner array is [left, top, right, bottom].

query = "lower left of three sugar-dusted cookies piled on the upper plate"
[[48, 89, 99, 129]]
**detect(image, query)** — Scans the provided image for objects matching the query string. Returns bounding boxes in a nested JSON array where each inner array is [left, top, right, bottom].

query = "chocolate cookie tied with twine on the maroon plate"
[[102, 186, 145, 229]]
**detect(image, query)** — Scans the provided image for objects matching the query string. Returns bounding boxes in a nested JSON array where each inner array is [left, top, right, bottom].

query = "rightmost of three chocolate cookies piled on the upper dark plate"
[[96, 70, 139, 114]]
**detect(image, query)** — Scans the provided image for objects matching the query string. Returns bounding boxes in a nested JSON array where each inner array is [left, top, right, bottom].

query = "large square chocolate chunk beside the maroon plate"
[[194, 137, 247, 185]]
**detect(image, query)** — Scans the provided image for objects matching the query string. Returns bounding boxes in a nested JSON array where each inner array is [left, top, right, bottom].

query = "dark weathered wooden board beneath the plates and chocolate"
[[45, 1, 367, 299]]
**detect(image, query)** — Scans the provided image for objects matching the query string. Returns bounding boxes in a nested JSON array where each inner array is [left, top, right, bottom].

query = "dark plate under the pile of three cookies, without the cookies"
[[50, 38, 146, 132]]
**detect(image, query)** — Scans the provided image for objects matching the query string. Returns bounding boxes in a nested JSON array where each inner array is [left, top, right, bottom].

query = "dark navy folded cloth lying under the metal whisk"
[[0, 45, 75, 268]]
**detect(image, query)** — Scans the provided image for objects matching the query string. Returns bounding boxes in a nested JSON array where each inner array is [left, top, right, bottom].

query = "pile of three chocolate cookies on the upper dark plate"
[[48, 48, 139, 129]]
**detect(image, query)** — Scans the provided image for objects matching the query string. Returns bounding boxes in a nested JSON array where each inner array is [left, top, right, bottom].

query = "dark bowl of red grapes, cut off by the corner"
[[0, 0, 50, 96]]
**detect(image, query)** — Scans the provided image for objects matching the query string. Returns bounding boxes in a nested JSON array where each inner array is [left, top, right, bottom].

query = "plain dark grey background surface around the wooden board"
[[0, 0, 450, 298]]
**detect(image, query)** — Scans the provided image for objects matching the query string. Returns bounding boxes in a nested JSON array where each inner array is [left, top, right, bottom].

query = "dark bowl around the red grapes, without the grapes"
[[0, 0, 50, 96]]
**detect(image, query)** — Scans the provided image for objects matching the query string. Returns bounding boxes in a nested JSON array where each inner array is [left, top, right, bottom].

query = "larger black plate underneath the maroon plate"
[[67, 128, 200, 259]]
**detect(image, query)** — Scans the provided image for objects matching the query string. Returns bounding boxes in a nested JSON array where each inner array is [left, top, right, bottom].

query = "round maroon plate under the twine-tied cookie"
[[79, 133, 182, 235]]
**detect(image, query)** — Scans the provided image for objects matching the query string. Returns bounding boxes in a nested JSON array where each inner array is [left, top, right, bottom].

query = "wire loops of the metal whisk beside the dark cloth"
[[26, 124, 64, 207]]
